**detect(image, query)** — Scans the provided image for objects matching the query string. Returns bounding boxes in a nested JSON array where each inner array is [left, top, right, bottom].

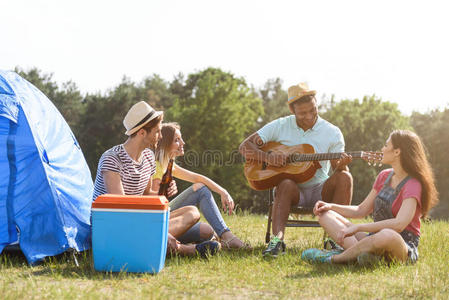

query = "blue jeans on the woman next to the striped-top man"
[[169, 186, 229, 243]]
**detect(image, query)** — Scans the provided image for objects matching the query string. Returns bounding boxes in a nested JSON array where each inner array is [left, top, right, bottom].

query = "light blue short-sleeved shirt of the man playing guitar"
[[257, 115, 345, 188]]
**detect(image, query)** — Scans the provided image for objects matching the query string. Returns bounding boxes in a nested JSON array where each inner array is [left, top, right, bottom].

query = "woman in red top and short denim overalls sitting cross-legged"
[[301, 130, 438, 263]]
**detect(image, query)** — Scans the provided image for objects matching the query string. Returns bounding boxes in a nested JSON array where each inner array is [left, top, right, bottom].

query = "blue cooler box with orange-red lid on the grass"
[[92, 194, 170, 273]]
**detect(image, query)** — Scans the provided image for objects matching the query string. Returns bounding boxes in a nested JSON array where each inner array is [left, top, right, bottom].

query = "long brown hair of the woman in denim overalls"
[[390, 130, 438, 217]]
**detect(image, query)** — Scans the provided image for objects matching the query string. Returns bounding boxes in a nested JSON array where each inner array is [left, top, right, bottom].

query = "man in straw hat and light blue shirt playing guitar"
[[239, 83, 352, 257]]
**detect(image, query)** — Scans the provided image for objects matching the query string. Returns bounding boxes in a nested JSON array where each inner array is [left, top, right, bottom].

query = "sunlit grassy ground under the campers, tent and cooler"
[[0, 215, 449, 299]]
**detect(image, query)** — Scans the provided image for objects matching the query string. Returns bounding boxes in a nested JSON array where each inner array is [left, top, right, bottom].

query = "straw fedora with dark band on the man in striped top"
[[123, 101, 163, 135]]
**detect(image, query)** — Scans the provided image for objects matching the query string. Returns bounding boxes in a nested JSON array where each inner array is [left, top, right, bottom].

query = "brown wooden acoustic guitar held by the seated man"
[[244, 142, 382, 190]]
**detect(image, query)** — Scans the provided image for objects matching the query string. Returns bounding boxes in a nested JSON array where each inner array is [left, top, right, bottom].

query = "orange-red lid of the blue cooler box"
[[92, 194, 168, 210]]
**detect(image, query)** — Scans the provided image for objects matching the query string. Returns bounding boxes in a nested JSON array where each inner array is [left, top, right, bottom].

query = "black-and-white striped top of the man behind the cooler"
[[92, 144, 156, 201]]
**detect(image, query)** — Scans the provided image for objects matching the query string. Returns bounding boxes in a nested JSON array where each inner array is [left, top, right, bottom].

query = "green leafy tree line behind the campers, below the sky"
[[15, 68, 449, 218]]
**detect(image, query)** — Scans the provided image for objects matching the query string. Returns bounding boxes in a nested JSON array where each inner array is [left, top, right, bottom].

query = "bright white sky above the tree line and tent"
[[0, 0, 449, 114]]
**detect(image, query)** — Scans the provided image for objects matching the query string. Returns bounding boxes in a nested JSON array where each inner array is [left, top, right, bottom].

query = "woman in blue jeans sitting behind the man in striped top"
[[153, 123, 250, 249]]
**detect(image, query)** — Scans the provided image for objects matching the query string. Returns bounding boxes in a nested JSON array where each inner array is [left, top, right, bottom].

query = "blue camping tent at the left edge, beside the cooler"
[[0, 70, 93, 263]]
